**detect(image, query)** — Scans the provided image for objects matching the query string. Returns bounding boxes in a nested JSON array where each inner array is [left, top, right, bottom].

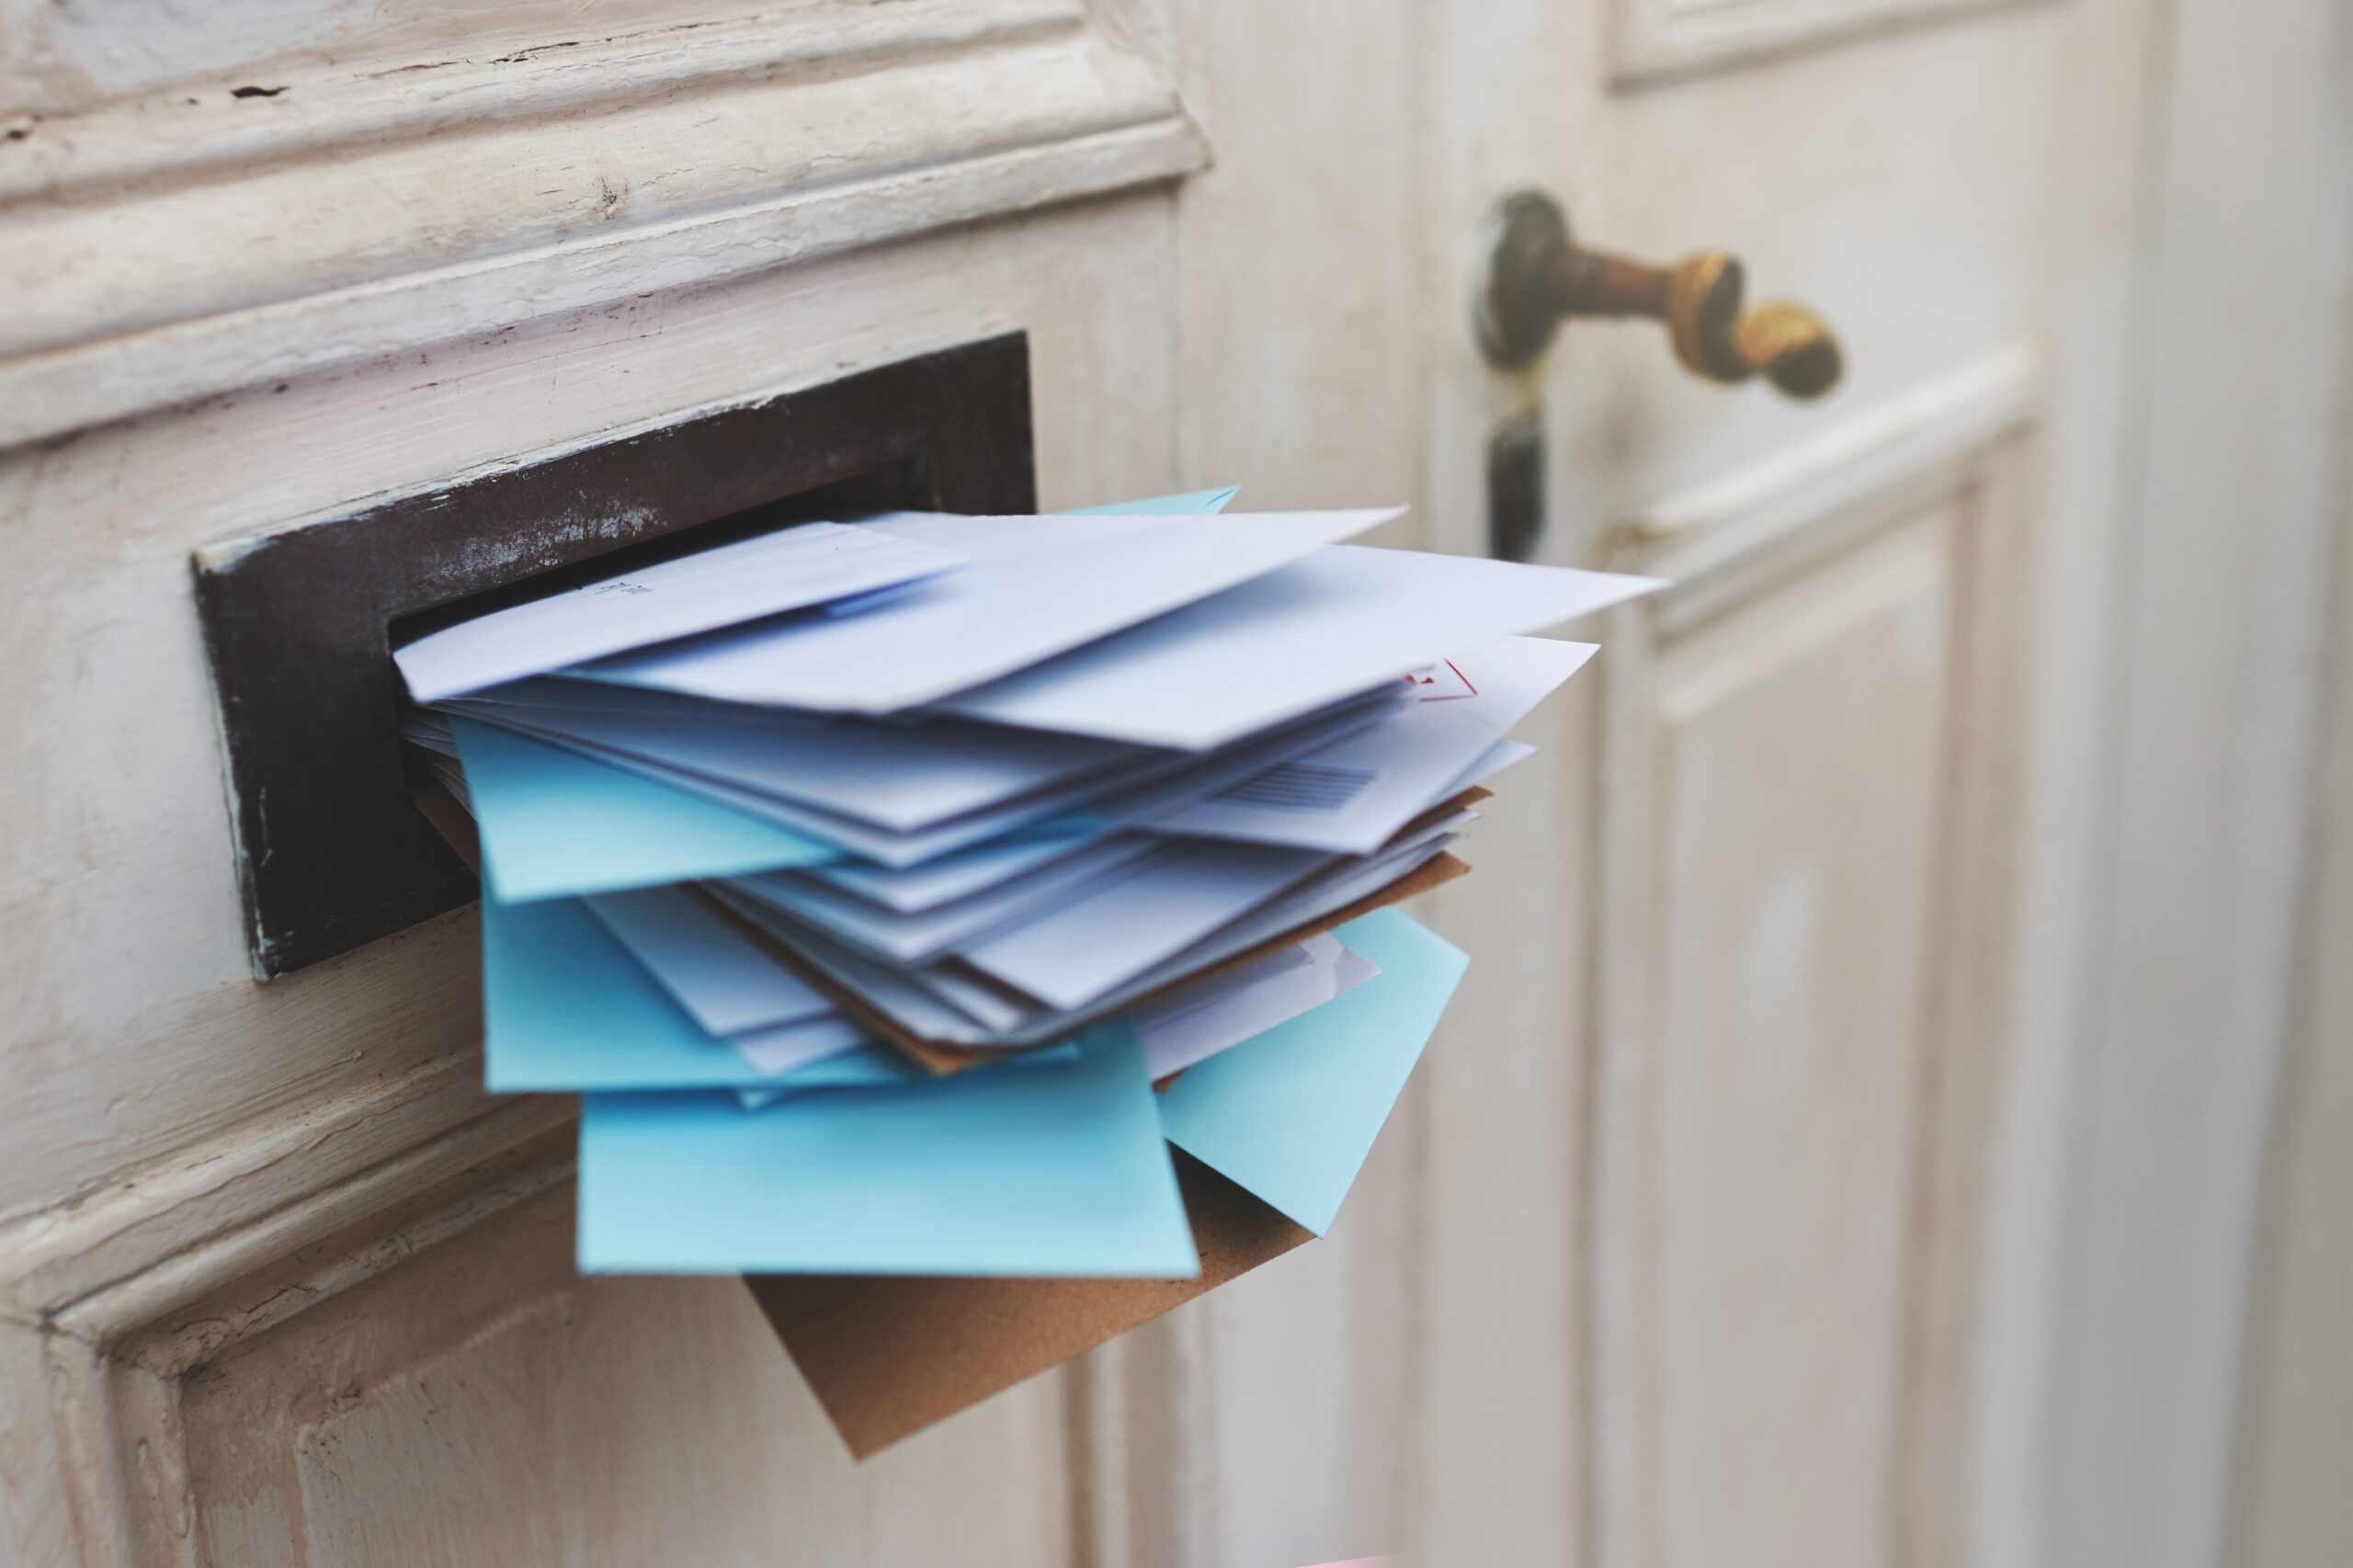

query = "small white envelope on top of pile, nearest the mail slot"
[[393, 523, 965, 701]]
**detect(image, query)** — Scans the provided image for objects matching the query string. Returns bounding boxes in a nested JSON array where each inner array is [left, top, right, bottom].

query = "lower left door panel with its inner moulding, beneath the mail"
[[6, 1102, 1068, 1563]]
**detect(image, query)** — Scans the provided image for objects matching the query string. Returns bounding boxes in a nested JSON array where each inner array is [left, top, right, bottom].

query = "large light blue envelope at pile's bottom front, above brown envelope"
[[579, 1027, 1200, 1278]]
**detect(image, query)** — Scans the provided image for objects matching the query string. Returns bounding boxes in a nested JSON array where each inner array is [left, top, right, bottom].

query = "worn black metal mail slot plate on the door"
[[195, 332, 1035, 977]]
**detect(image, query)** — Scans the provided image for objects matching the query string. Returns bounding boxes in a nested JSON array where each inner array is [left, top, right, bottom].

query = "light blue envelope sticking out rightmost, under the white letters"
[[1160, 909, 1471, 1236]]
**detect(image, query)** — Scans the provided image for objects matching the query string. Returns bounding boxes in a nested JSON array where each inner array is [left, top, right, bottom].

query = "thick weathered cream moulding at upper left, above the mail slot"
[[0, 0, 1210, 448]]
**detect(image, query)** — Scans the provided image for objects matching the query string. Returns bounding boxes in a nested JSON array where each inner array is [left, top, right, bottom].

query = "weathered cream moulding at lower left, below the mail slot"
[[0, 1036, 572, 1568]]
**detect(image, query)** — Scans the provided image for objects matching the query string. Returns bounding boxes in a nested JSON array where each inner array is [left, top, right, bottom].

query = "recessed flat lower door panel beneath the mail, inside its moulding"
[[181, 1187, 1068, 1568]]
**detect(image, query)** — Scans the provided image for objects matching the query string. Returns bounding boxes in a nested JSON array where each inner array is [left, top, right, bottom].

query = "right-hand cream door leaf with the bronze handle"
[[1383, 0, 2143, 1568]]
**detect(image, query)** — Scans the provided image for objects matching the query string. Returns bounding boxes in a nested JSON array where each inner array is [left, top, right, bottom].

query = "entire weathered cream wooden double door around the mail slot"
[[0, 0, 2202, 1568]]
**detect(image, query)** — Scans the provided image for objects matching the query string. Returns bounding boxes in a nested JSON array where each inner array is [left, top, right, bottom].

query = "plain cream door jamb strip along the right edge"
[[2050, 0, 2353, 1568]]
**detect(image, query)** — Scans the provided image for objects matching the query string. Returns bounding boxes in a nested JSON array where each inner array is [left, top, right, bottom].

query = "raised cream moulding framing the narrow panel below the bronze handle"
[[1584, 339, 2050, 1568]]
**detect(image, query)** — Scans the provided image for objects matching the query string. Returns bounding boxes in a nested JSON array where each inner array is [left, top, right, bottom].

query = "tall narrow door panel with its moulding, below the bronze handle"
[[1593, 379, 2040, 1563]]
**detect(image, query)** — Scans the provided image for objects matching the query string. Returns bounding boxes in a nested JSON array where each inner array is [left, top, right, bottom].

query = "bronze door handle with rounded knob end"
[[1478, 190, 1845, 398]]
